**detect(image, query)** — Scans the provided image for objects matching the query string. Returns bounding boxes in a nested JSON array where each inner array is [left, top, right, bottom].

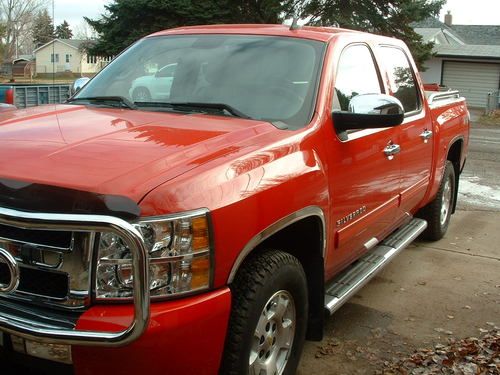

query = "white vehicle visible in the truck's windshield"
[[129, 63, 177, 102]]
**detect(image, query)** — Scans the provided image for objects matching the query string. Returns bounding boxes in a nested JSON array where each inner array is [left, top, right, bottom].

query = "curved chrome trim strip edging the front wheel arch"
[[227, 206, 326, 284]]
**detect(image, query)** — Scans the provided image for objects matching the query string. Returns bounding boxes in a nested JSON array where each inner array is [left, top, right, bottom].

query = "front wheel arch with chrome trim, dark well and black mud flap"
[[227, 206, 326, 340]]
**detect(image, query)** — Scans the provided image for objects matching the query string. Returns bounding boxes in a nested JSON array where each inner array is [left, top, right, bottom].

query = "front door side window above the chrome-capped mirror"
[[332, 44, 382, 111]]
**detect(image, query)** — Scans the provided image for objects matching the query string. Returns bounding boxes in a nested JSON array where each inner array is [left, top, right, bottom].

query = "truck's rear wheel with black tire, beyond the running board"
[[417, 160, 456, 241]]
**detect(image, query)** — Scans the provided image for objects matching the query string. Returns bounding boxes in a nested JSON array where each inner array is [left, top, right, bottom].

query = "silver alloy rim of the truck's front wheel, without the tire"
[[249, 290, 296, 375]]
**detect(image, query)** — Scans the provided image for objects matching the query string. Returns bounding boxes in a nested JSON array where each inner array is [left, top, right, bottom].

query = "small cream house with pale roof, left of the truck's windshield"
[[33, 39, 112, 75]]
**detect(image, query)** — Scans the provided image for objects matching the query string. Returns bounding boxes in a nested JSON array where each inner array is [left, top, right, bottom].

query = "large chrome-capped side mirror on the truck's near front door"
[[332, 94, 405, 132]]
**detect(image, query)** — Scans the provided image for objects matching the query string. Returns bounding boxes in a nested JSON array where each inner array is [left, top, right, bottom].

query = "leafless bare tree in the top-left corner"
[[0, 0, 47, 59]]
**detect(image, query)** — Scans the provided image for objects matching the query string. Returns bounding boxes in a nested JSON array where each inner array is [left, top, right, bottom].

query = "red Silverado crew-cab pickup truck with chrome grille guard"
[[0, 25, 469, 375]]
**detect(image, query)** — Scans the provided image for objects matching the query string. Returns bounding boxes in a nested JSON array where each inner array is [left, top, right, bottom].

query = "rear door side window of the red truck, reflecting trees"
[[380, 46, 420, 113]]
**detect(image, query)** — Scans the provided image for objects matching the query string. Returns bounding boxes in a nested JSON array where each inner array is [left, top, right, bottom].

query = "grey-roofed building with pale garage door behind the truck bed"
[[413, 12, 500, 108]]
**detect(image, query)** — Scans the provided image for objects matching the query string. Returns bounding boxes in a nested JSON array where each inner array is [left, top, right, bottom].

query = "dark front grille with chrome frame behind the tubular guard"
[[0, 224, 95, 309]]
